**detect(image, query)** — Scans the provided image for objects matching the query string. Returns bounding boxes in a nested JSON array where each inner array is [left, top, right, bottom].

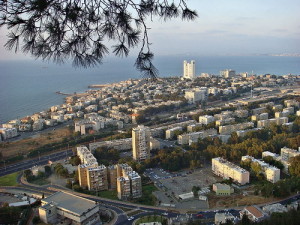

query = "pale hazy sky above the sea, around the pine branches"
[[0, 0, 300, 59]]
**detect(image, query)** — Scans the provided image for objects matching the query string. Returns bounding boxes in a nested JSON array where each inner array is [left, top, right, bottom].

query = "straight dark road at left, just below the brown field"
[[0, 149, 73, 177]]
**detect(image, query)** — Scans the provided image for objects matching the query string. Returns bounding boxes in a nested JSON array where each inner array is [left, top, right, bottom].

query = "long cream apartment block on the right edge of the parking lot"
[[212, 157, 250, 185]]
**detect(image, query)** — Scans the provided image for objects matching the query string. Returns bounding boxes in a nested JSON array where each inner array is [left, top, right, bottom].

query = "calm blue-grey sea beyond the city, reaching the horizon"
[[0, 55, 300, 124]]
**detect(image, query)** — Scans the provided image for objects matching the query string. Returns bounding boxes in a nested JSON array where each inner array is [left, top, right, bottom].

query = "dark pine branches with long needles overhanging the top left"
[[0, 0, 197, 78]]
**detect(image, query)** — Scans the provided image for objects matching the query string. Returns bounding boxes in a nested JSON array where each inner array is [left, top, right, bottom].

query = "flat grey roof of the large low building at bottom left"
[[42, 192, 96, 216]]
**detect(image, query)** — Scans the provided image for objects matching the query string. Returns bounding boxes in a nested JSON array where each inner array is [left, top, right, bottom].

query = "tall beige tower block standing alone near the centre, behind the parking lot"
[[132, 125, 150, 161]]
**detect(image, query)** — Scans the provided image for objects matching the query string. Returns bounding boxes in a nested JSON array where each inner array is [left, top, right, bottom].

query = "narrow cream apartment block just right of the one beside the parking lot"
[[242, 155, 280, 183]]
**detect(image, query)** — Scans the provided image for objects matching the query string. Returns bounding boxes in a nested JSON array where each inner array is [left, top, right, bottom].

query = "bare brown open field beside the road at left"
[[0, 127, 72, 158]]
